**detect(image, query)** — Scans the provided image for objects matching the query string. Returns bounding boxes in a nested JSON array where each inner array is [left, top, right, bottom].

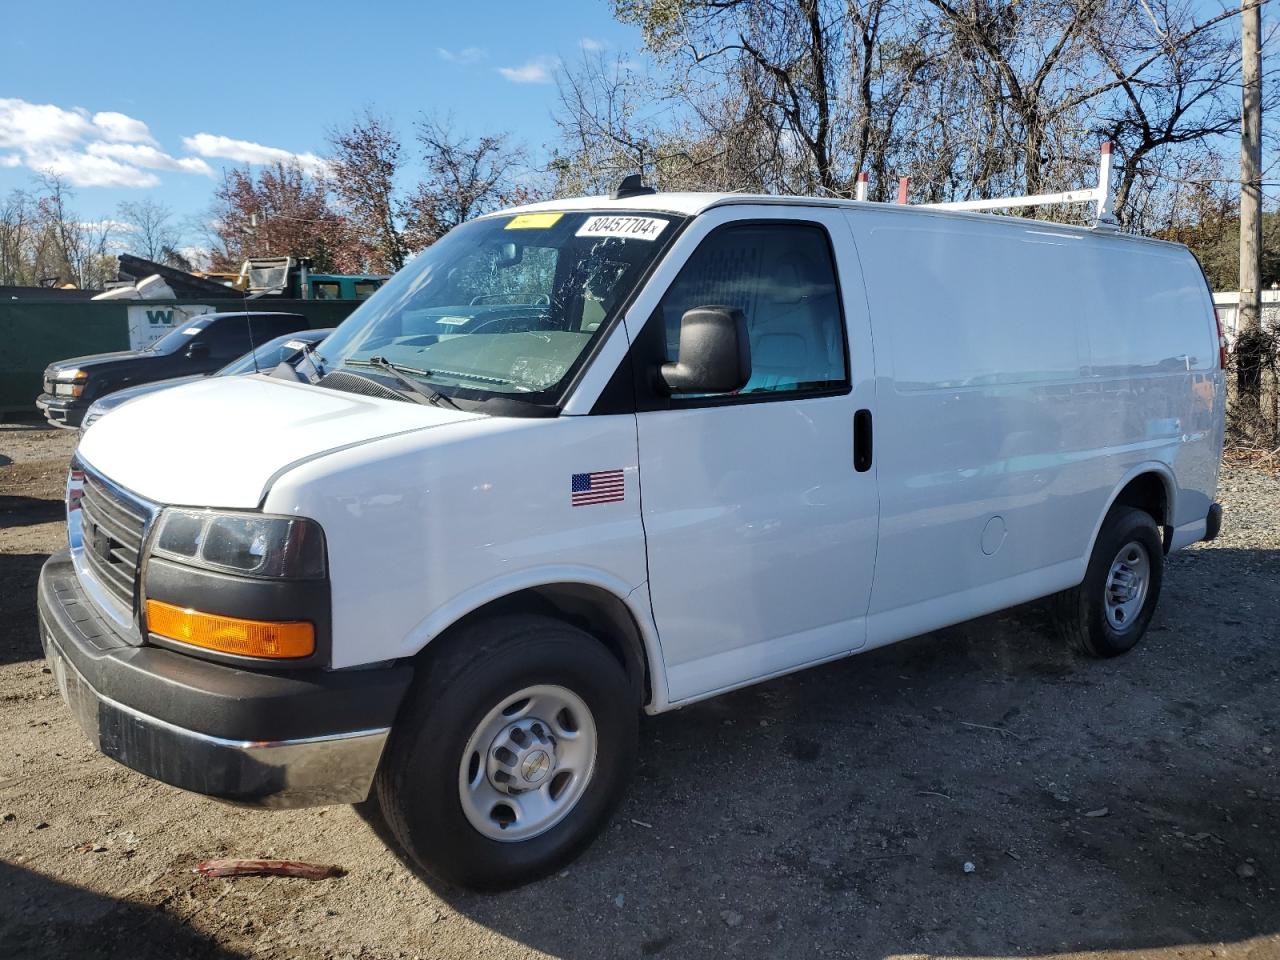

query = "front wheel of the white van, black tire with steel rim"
[[376, 616, 640, 890]]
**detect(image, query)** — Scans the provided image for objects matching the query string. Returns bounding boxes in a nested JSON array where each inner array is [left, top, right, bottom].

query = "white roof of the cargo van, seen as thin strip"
[[489, 193, 1184, 247]]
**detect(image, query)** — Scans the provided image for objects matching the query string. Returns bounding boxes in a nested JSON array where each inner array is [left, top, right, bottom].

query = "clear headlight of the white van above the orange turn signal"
[[152, 507, 325, 580]]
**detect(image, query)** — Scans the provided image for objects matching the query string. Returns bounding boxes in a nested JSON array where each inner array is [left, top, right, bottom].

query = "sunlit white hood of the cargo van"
[[77, 375, 484, 509]]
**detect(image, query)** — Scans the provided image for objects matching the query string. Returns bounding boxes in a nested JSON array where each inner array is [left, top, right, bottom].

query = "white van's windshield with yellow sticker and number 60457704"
[[320, 212, 675, 403]]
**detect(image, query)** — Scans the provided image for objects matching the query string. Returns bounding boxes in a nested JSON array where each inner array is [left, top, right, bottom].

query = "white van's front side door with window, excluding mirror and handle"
[[637, 206, 878, 701]]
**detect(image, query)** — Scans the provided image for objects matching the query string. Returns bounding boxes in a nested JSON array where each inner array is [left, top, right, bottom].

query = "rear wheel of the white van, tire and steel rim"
[[1055, 507, 1165, 657]]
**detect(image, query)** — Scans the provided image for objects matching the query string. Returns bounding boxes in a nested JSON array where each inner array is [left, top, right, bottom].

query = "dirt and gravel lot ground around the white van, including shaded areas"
[[0, 425, 1280, 960]]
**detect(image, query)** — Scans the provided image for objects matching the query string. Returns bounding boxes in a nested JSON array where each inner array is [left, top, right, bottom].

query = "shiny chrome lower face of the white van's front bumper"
[[42, 631, 390, 808]]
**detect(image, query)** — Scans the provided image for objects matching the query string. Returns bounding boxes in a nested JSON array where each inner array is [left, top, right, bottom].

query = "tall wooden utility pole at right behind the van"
[[1235, 0, 1262, 412]]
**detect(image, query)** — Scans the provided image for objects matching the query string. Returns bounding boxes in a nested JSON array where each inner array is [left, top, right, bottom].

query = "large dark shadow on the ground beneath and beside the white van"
[[389, 549, 1280, 960]]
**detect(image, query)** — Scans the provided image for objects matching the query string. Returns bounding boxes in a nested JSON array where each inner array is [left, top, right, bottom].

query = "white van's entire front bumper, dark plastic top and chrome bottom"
[[38, 553, 412, 808]]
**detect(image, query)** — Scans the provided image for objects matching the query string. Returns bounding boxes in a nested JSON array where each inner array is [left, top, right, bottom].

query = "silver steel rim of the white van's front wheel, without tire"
[[458, 685, 596, 841]]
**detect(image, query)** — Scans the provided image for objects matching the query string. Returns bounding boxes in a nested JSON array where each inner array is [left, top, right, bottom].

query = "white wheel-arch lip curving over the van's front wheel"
[[399, 564, 668, 713]]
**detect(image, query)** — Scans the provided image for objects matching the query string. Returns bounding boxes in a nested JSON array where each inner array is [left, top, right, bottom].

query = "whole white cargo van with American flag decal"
[[40, 184, 1224, 887]]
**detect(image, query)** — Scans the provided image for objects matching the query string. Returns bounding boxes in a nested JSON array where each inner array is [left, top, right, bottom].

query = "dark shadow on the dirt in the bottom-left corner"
[[0, 861, 244, 960]]
